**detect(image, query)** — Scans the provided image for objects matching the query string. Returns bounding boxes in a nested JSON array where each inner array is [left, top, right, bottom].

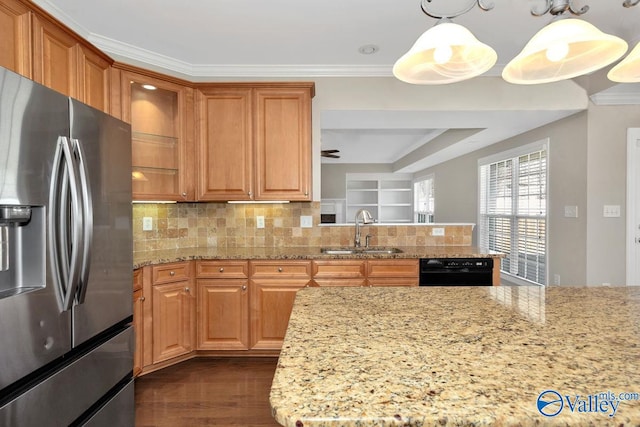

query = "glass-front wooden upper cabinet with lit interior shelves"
[[119, 71, 194, 201]]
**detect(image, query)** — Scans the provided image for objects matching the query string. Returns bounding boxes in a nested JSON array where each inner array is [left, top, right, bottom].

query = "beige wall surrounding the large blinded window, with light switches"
[[412, 104, 640, 286]]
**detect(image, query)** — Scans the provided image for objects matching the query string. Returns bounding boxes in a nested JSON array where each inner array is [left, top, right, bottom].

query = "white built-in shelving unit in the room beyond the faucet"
[[346, 173, 413, 224]]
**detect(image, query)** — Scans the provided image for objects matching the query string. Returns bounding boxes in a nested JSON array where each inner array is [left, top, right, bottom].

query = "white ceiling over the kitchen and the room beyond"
[[34, 0, 640, 171]]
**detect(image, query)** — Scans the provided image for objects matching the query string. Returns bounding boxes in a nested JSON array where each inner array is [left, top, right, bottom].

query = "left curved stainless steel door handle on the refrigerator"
[[49, 136, 84, 312]]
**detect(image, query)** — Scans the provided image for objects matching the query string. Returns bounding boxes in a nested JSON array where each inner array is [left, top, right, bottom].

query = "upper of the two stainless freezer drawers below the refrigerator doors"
[[0, 326, 134, 427]]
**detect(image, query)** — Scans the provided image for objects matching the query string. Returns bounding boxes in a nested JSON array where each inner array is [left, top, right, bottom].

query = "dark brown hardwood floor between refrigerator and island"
[[135, 358, 279, 427]]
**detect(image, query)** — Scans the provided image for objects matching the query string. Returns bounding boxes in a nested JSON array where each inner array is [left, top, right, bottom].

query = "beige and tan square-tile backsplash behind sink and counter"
[[133, 202, 473, 252]]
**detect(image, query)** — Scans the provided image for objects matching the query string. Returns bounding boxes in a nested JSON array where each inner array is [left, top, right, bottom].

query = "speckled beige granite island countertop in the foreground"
[[270, 286, 640, 427]]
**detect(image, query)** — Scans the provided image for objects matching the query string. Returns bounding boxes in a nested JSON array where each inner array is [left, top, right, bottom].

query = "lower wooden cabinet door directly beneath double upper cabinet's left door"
[[197, 279, 249, 350]]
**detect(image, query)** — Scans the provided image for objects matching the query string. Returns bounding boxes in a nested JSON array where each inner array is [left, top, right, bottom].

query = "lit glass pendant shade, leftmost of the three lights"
[[393, 18, 498, 85]]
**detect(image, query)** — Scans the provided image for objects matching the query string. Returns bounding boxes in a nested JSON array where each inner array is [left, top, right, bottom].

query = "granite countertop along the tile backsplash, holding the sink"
[[133, 246, 504, 269]]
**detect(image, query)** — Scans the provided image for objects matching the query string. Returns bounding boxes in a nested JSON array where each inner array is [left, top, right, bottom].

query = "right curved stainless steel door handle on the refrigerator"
[[71, 139, 93, 304]]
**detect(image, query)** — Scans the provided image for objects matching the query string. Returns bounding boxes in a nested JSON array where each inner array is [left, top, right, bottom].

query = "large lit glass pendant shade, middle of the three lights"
[[502, 18, 628, 84]]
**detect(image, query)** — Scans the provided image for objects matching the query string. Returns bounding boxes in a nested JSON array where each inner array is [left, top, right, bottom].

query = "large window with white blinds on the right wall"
[[478, 141, 547, 285]]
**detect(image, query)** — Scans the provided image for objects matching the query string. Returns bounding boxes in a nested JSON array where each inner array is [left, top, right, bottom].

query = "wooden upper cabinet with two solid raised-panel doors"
[[197, 82, 314, 201]]
